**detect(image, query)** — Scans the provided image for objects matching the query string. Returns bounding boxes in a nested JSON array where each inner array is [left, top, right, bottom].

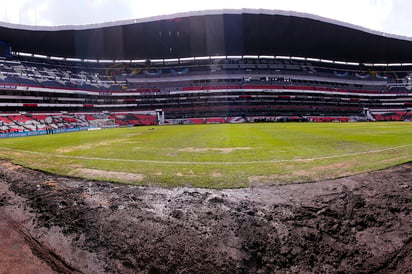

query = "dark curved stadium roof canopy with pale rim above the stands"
[[0, 9, 412, 63]]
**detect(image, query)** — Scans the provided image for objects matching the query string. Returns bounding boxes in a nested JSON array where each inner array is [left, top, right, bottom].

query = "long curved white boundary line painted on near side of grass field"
[[0, 144, 412, 165]]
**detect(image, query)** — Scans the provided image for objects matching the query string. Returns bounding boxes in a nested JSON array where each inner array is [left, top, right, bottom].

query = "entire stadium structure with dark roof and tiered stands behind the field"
[[0, 10, 412, 133]]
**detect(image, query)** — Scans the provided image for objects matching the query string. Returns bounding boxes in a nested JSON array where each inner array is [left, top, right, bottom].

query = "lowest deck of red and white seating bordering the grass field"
[[0, 110, 412, 133]]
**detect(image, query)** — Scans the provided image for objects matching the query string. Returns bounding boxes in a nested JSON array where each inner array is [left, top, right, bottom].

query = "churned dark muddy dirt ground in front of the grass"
[[0, 161, 412, 273]]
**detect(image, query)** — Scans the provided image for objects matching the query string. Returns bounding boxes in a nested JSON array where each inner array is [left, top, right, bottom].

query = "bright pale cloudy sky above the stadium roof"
[[0, 0, 412, 37]]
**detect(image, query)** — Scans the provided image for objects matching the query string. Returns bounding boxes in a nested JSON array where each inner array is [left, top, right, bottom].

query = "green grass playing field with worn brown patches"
[[0, 122, 412, 188]]
